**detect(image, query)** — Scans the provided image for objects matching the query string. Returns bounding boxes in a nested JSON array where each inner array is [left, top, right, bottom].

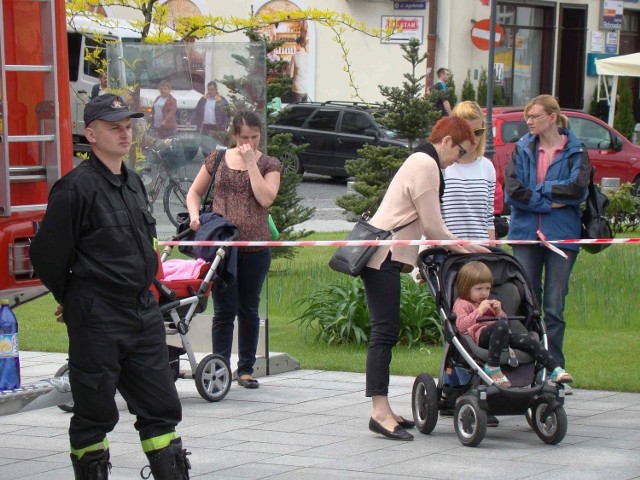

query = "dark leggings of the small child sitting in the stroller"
[[478, 318, 560, 372]]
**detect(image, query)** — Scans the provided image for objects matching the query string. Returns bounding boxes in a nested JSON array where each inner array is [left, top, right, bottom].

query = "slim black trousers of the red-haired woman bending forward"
[[360, 253, 402, 397]]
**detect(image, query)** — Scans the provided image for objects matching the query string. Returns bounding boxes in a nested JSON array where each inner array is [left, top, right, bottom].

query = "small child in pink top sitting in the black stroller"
[[453, 261, 573, 388]]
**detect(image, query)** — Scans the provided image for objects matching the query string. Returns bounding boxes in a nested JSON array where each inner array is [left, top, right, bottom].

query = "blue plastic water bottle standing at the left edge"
[[0, 300, 20, 391]]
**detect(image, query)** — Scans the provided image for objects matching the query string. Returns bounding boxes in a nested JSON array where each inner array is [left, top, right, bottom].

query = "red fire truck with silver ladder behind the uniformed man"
[[0, 0, 73, 304]]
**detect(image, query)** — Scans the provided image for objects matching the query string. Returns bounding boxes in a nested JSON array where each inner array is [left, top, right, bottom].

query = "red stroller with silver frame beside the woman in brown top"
[[151, 229, 240, 402]]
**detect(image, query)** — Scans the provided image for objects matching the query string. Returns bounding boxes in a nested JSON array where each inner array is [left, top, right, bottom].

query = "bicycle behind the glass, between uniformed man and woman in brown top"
[[143, 141, 193, 227]]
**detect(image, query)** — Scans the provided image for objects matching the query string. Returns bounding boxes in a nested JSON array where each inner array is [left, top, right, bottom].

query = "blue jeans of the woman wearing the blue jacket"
[[513, 245, 578, 368]]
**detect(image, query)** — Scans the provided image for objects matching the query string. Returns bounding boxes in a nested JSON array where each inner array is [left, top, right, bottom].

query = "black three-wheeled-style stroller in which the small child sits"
[[411, 248, 567, 447]]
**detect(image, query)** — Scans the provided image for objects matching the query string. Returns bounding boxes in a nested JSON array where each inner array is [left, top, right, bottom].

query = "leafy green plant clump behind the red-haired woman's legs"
[[294, 275, 443, 347]]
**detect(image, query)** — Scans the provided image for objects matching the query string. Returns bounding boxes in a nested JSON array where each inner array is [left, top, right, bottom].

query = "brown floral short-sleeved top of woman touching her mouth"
[[204, 150, 282, 252]]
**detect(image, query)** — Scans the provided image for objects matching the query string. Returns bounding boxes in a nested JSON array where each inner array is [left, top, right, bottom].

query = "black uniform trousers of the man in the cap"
[[64, 291, 182, 450]]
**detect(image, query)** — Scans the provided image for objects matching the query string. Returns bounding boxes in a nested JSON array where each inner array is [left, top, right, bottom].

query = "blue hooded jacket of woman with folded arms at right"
[[504, 128, 590, 250]]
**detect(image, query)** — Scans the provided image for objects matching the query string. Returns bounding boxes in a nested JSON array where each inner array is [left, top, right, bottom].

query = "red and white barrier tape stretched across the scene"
[[158, 238, 640, 247]]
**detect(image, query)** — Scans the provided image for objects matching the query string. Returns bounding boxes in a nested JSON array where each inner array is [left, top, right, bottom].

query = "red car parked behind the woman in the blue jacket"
[[492, 107, 640, 214]]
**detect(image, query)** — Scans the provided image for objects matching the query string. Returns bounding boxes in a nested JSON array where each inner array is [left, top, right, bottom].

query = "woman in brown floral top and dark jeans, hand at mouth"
[[187, 111, 282, 388]]
